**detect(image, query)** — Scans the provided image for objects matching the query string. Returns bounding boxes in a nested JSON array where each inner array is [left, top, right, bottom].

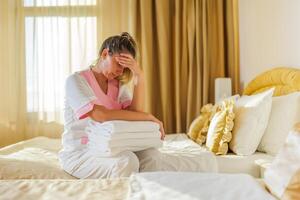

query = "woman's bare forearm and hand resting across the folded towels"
[[87, 105, 165, 139]]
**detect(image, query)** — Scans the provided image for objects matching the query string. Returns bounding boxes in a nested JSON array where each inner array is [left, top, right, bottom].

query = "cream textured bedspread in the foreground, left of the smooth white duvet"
[[0, 178, 128, 200]]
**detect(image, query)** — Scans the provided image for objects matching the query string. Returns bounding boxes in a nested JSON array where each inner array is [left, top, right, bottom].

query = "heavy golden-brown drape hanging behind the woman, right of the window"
[[135, 0, 239, 133]]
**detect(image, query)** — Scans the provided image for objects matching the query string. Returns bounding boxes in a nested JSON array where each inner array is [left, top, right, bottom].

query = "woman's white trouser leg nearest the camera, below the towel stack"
[[59, 148, 139, 179]]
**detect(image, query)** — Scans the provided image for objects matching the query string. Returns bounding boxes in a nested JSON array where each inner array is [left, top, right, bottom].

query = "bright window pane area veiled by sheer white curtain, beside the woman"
[[23, 0, 98, 137]]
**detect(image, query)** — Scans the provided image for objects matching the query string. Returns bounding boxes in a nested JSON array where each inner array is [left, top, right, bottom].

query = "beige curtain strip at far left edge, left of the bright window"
[[0, 0, 26, 146]]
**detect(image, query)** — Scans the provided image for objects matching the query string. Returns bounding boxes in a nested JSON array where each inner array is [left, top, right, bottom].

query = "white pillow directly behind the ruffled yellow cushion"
[[229, 88, 274, 155]]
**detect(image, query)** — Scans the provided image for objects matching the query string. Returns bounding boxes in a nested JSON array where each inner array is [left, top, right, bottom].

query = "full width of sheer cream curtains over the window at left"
[[0, 0, 100, 146]]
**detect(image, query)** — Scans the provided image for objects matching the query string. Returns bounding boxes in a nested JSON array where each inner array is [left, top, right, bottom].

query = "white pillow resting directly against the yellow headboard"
[[258, 92, 300, 155]]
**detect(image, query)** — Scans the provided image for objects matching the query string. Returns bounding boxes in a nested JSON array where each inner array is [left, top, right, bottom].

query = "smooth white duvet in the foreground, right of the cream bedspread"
[[128, 172, 275, 200]]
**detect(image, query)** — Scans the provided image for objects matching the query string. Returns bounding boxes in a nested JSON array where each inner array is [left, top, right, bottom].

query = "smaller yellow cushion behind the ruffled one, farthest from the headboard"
[[187, 104, 215, 145]]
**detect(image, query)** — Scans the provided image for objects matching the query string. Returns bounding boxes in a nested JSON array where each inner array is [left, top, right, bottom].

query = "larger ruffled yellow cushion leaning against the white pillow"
[[206, 99, 234, 155]]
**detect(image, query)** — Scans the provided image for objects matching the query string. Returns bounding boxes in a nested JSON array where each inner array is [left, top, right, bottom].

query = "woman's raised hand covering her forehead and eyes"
[[116, 53, 142, 76]]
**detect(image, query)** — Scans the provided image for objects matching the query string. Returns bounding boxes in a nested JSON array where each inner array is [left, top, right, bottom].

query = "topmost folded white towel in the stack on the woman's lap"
[[89, 120, 159, 135]]
